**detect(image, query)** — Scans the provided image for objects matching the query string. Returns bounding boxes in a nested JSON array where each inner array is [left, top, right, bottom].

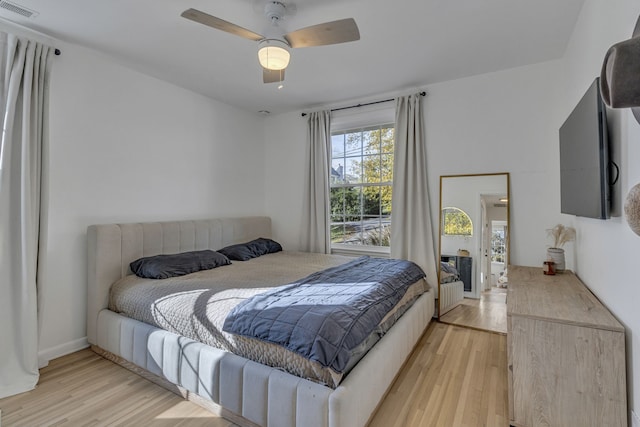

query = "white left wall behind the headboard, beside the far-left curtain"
[[40, 42, 265, 359]]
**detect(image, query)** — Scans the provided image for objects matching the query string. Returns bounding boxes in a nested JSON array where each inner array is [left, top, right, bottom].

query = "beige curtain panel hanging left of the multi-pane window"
[[300, 110, 331, 254]]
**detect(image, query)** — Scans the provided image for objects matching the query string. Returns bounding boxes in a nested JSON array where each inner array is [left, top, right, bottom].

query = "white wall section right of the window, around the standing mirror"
[[425, 61, 570, 266]]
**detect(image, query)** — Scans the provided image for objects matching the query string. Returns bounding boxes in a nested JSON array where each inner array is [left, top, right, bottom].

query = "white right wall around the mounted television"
[[558, 0, 640, 420]]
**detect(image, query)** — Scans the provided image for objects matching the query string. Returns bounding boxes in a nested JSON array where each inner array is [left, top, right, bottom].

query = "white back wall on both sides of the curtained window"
[[265, 61, 571, 266]]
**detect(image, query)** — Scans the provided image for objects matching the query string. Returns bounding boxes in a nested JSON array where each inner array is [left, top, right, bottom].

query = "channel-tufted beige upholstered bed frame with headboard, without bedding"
[[87, 217, 434, 427]]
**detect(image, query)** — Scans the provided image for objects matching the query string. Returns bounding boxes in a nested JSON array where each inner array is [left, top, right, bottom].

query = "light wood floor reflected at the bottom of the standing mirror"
[[440, 286, 507, 334]]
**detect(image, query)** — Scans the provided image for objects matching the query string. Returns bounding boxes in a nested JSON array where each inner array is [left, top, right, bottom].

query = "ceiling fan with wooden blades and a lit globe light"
[[180, 1, 360, 83]]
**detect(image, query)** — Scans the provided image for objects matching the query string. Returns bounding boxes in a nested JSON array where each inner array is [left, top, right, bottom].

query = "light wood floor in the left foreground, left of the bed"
[[0, 349, 234, 427]]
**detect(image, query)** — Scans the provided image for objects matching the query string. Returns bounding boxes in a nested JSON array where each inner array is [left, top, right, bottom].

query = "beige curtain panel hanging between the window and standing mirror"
[[391, 93, 438, 286]]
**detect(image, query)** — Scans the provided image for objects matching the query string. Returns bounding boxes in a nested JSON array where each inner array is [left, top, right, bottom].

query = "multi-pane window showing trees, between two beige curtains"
[[329, 124, 394, 248]]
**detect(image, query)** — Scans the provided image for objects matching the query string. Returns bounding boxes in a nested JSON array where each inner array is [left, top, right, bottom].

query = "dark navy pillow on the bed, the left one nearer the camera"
[[129, 250, 231, 279]]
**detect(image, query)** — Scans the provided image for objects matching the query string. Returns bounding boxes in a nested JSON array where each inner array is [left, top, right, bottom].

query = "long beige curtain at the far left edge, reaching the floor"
[[0, 32, 53, 398]]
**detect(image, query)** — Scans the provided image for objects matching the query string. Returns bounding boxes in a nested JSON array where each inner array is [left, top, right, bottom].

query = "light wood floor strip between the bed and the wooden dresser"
[[369, 322, 509, 427]]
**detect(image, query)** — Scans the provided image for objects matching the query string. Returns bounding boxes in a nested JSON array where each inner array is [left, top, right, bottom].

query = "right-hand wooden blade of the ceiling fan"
[[284, 18, 360, 47]]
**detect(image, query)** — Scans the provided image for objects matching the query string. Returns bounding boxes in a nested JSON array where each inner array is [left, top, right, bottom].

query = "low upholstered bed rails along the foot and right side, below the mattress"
[[96, 292, 434, 427]]
